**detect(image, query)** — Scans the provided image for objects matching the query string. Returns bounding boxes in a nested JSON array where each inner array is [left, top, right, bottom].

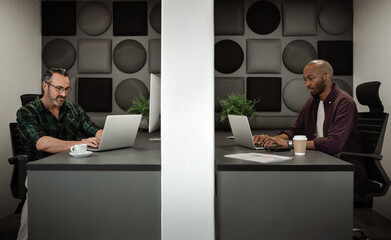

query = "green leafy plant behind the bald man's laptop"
[[219, 93, 259, 126]]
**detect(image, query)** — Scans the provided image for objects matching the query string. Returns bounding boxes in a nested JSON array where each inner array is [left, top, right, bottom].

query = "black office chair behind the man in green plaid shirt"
[[8, 94, 38, 213]]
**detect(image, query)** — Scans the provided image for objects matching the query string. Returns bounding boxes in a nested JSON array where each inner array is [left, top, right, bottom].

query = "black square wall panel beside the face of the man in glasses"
[[77, 78, 113, 112]]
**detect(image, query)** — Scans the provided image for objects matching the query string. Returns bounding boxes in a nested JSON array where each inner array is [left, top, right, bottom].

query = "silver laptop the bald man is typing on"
[[228, 115, 263, 150]]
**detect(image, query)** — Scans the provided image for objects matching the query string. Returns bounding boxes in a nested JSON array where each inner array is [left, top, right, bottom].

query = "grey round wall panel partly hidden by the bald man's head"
[[282, 40, 316, 74]]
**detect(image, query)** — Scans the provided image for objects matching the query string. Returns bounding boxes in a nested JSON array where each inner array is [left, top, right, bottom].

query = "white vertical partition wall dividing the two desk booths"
[[161, 0, 214, 240]]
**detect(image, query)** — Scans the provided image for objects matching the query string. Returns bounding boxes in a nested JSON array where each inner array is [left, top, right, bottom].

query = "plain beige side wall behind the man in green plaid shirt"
[[0, 0, 41, 218]]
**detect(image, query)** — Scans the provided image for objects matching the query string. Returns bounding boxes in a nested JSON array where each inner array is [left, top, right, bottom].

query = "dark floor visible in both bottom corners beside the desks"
[[0, 208, 391, 240]]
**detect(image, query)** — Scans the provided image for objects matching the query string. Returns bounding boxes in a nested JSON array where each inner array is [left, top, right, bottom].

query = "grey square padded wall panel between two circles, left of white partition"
[[77, 39, 111, 73]]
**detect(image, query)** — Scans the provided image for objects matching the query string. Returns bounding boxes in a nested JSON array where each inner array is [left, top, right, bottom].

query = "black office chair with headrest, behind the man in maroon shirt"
[[356, 82, 390, 196]]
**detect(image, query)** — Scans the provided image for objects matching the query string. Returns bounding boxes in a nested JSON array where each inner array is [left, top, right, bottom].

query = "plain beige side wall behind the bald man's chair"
[[353, 0, 391, 219]]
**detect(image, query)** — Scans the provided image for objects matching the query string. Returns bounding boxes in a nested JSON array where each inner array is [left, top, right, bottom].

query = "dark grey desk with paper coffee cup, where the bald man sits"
[[216, 133, 354, 240]]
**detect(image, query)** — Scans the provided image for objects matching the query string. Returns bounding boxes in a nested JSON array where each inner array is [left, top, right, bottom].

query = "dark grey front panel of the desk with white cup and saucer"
[[28, 171, 160, 240]]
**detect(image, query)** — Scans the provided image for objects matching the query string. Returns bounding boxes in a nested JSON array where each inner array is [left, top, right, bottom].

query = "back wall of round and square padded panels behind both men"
[[42, 0, 353, 129]]
